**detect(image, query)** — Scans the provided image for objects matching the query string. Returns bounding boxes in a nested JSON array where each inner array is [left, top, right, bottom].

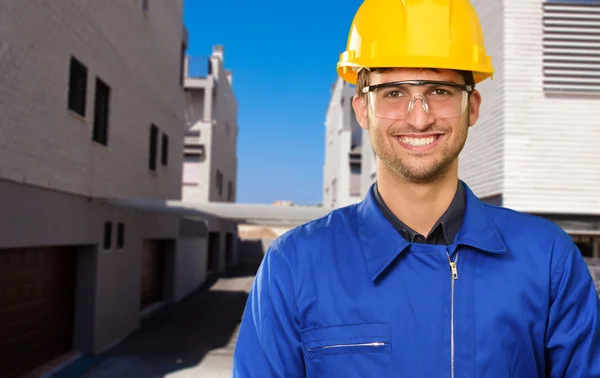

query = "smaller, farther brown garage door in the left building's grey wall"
[[140, 240, 165, 309]]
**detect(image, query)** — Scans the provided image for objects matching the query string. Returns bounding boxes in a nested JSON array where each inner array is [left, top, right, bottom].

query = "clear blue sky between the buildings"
[[184, 0, 361, 204]]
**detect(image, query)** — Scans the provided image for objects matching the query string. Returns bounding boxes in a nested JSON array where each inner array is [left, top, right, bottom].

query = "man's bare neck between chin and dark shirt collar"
[[377, 163, 458, 236]]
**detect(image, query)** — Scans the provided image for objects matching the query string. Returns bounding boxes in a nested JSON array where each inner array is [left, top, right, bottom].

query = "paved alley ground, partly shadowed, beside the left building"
[[68, 265, 256, 378]]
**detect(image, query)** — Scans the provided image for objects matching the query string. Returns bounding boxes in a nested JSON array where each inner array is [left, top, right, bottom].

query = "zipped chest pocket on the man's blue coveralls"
[[302, 323, 393, 378]]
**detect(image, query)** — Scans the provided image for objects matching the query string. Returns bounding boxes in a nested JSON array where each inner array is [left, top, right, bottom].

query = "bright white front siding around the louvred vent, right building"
[[504, 0, 600, 214]]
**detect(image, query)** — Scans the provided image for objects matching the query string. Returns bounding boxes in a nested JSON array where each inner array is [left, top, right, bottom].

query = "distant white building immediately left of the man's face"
[[323, 78, 370, 208]]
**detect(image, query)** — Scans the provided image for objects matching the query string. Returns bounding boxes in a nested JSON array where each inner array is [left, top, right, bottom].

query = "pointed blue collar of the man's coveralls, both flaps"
[[357, 182, 507, 280]]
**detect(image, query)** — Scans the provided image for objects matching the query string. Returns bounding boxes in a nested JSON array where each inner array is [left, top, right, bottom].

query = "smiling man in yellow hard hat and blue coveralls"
[[233, 0, 600, 378]]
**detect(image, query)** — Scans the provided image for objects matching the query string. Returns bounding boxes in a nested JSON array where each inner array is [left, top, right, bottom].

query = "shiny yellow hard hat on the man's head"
[[337, 0, 494, 84]]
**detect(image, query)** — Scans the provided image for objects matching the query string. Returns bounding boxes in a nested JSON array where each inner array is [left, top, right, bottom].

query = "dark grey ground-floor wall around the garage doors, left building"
[[0, 180, 195, 352]]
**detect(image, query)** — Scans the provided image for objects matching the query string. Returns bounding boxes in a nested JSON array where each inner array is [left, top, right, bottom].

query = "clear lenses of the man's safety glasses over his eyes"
[[369, 84, 469, 120]]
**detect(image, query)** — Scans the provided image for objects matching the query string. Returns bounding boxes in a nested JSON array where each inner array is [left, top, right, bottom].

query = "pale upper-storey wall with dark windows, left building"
[[0, 0, 185, 199]]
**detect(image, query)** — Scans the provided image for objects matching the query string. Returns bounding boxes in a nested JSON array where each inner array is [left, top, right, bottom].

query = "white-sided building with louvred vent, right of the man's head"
[[460, 0, 600, 258]]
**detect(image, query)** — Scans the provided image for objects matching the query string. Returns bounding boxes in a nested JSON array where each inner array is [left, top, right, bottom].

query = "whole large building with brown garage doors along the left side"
[[0, 0, 234, 378]]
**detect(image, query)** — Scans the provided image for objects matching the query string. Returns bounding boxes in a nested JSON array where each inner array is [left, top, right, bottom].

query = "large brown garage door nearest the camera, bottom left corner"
[[0, 247, 77, 378]]
